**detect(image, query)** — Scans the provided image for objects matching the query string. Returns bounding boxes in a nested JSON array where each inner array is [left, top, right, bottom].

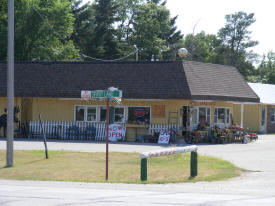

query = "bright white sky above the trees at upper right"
[[84, 0, 275, 55]]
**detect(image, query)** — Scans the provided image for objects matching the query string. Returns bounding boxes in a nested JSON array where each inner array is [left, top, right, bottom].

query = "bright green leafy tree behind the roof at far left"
[[0, 0, 79, 61]]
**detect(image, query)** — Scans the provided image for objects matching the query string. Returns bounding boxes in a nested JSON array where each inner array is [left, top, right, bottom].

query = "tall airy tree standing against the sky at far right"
[[218, 11, 258, 76]]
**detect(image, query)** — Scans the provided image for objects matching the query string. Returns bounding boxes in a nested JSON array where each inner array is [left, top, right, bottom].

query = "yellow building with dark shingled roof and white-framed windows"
[[0, 61, 259, 141]]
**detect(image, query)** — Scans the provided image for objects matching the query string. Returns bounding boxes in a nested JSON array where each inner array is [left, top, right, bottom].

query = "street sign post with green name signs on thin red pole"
[[81, 87, 122, 180]]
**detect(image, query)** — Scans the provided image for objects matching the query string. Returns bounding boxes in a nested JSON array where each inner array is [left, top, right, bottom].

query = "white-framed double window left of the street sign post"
[[75, 106, 96, 122]]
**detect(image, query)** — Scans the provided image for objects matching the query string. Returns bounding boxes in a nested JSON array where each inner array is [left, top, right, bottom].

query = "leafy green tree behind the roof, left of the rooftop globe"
[[130, 1, 182, 60]]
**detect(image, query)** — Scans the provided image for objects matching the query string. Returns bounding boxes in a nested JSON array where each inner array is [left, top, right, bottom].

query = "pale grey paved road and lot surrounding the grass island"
[[0, 135, 275, 206]]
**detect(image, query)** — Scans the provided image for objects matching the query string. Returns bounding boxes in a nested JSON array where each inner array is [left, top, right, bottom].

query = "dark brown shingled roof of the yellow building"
[[0, 61, 259, 102]]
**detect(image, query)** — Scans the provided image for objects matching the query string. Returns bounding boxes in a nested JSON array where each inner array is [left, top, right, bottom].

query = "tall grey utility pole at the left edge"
[[7, 0, 14, 167]]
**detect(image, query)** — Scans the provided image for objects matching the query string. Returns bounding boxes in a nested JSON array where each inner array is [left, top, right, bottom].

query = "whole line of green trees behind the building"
[[0, 0, 275, 83]]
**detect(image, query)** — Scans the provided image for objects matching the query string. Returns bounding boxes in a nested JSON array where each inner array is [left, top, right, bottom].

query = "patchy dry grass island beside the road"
[[0, 150, 244, 183]]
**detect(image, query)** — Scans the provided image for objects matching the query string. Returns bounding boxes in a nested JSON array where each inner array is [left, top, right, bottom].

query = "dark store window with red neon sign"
[[128, 107, 150, 124]]
